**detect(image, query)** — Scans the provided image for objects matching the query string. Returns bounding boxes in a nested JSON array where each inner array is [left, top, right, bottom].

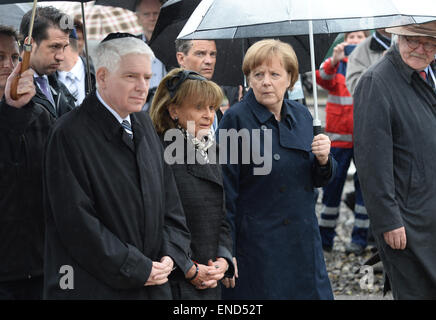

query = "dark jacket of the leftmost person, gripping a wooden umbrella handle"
[[0, 99, 54, 282]]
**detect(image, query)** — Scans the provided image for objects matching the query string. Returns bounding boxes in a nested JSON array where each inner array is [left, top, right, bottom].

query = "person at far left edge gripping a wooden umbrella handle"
[[0, 26, 53, 300]]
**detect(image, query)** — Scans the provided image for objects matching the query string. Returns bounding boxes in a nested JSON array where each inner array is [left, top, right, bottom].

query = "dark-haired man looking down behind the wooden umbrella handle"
[[20, 7, 75, 118]]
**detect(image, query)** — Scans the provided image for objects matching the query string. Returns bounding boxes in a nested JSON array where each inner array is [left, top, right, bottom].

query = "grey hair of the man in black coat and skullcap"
[[94, 37, 155, 72]]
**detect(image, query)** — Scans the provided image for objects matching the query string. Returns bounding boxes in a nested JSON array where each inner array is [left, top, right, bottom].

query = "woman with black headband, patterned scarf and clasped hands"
[[150, 69, 234, 300]]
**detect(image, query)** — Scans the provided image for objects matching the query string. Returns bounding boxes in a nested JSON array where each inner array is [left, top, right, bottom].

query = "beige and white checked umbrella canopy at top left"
[[40, 1, 142, 41]]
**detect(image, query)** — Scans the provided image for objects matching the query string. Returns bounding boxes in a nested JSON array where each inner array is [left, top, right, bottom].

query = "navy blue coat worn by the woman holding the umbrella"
[[218, 90, 336, 299]]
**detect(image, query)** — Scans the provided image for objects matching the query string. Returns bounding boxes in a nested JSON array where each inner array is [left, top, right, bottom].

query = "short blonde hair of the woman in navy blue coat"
[[242, 39, 298, 88]]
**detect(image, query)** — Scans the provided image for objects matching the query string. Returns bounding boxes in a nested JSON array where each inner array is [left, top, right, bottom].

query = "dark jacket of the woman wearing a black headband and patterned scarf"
[[161, 129, 234, 300]]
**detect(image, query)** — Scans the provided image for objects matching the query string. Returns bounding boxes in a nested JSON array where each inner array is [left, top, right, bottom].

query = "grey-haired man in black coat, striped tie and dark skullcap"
[[44, 34, 191, 299]]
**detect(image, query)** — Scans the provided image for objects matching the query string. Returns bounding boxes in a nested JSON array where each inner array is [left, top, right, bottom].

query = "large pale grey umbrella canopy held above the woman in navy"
[[179, 0, 436, 39]]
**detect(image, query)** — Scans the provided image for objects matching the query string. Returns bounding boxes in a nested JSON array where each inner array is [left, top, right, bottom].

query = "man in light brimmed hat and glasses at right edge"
[[354, 22, 436, 299]]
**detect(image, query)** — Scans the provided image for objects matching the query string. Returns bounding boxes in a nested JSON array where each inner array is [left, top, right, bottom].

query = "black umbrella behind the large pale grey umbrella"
[[150, 0, 337, 86]]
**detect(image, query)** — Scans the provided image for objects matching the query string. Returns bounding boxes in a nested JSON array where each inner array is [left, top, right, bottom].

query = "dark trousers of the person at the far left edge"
[[0, 276, 44, 300]]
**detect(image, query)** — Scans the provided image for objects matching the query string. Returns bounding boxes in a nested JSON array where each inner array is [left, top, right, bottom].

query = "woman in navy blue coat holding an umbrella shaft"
[[218, 40, 336, 299]]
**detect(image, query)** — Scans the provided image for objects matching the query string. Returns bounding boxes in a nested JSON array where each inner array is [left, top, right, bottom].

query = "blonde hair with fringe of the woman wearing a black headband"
[[150, 68, 224, 134]]
